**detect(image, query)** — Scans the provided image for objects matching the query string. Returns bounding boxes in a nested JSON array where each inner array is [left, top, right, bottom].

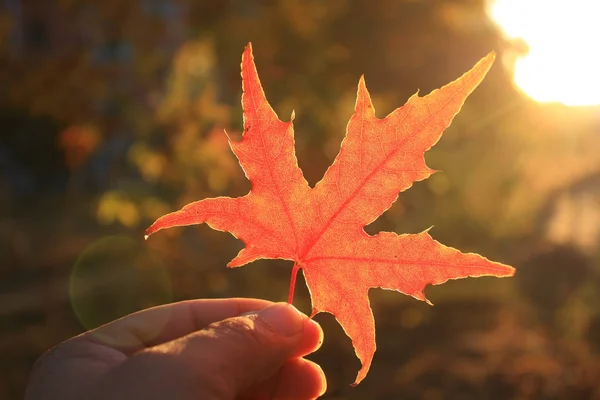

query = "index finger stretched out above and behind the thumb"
[[77, 298, 273, 355]]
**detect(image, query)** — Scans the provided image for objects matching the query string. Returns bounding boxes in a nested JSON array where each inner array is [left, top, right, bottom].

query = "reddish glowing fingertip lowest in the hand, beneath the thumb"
[[240, 358, 327, 400]]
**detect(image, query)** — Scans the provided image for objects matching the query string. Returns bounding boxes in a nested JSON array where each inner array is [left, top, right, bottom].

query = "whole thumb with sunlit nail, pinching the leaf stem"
[[91, 303, 319, 399]]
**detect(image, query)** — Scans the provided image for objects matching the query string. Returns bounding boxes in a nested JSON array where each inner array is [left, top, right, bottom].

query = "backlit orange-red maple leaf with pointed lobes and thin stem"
[[146, 45, 514, 385]]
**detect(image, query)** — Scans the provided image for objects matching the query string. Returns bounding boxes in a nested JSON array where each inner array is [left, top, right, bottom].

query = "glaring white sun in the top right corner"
[[488, 0, 600, 106]]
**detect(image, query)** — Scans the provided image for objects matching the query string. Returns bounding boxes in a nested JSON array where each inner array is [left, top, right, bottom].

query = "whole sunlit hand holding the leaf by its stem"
[[25, 299, 326, 400]]
